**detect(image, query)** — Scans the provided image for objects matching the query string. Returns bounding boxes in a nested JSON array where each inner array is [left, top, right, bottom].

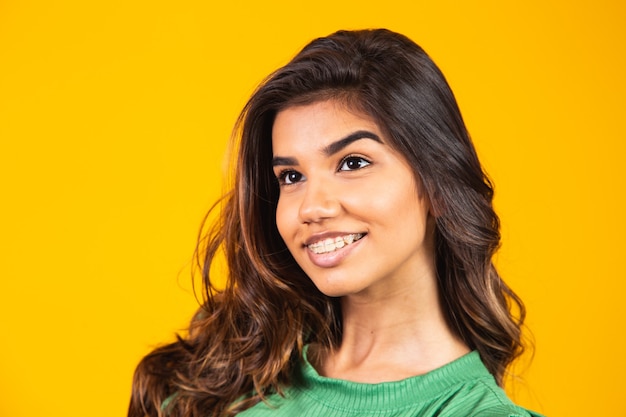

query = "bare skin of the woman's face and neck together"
[[272, 100, 469, 383]]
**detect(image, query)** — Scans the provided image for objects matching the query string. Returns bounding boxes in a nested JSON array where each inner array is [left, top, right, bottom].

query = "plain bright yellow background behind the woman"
[[0, 0, 626, 417]]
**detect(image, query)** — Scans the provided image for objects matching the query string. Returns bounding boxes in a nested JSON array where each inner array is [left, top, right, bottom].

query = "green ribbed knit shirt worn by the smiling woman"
[[238, 352, 539, 417]]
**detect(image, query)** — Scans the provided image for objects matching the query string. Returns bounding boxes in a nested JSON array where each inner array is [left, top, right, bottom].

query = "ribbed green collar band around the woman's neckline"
[[294, 349, 493, 412]]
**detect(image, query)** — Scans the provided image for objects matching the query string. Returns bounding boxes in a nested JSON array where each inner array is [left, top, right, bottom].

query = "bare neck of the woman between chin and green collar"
[[315, 270, 469, 383]]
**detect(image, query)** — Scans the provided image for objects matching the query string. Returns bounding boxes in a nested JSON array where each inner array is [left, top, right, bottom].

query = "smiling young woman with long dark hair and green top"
[[129, 29, 533, 417]]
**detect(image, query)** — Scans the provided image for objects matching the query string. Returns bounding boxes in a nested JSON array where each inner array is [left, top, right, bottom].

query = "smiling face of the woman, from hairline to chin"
[[272, 100, 434, 297]]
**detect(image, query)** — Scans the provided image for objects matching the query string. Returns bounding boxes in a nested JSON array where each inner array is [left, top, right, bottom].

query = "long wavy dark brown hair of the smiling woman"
[[128, 29, 525, 417]]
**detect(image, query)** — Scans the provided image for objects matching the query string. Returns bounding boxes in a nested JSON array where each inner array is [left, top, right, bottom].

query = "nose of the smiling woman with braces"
[[298, 179, 341, 223]]
